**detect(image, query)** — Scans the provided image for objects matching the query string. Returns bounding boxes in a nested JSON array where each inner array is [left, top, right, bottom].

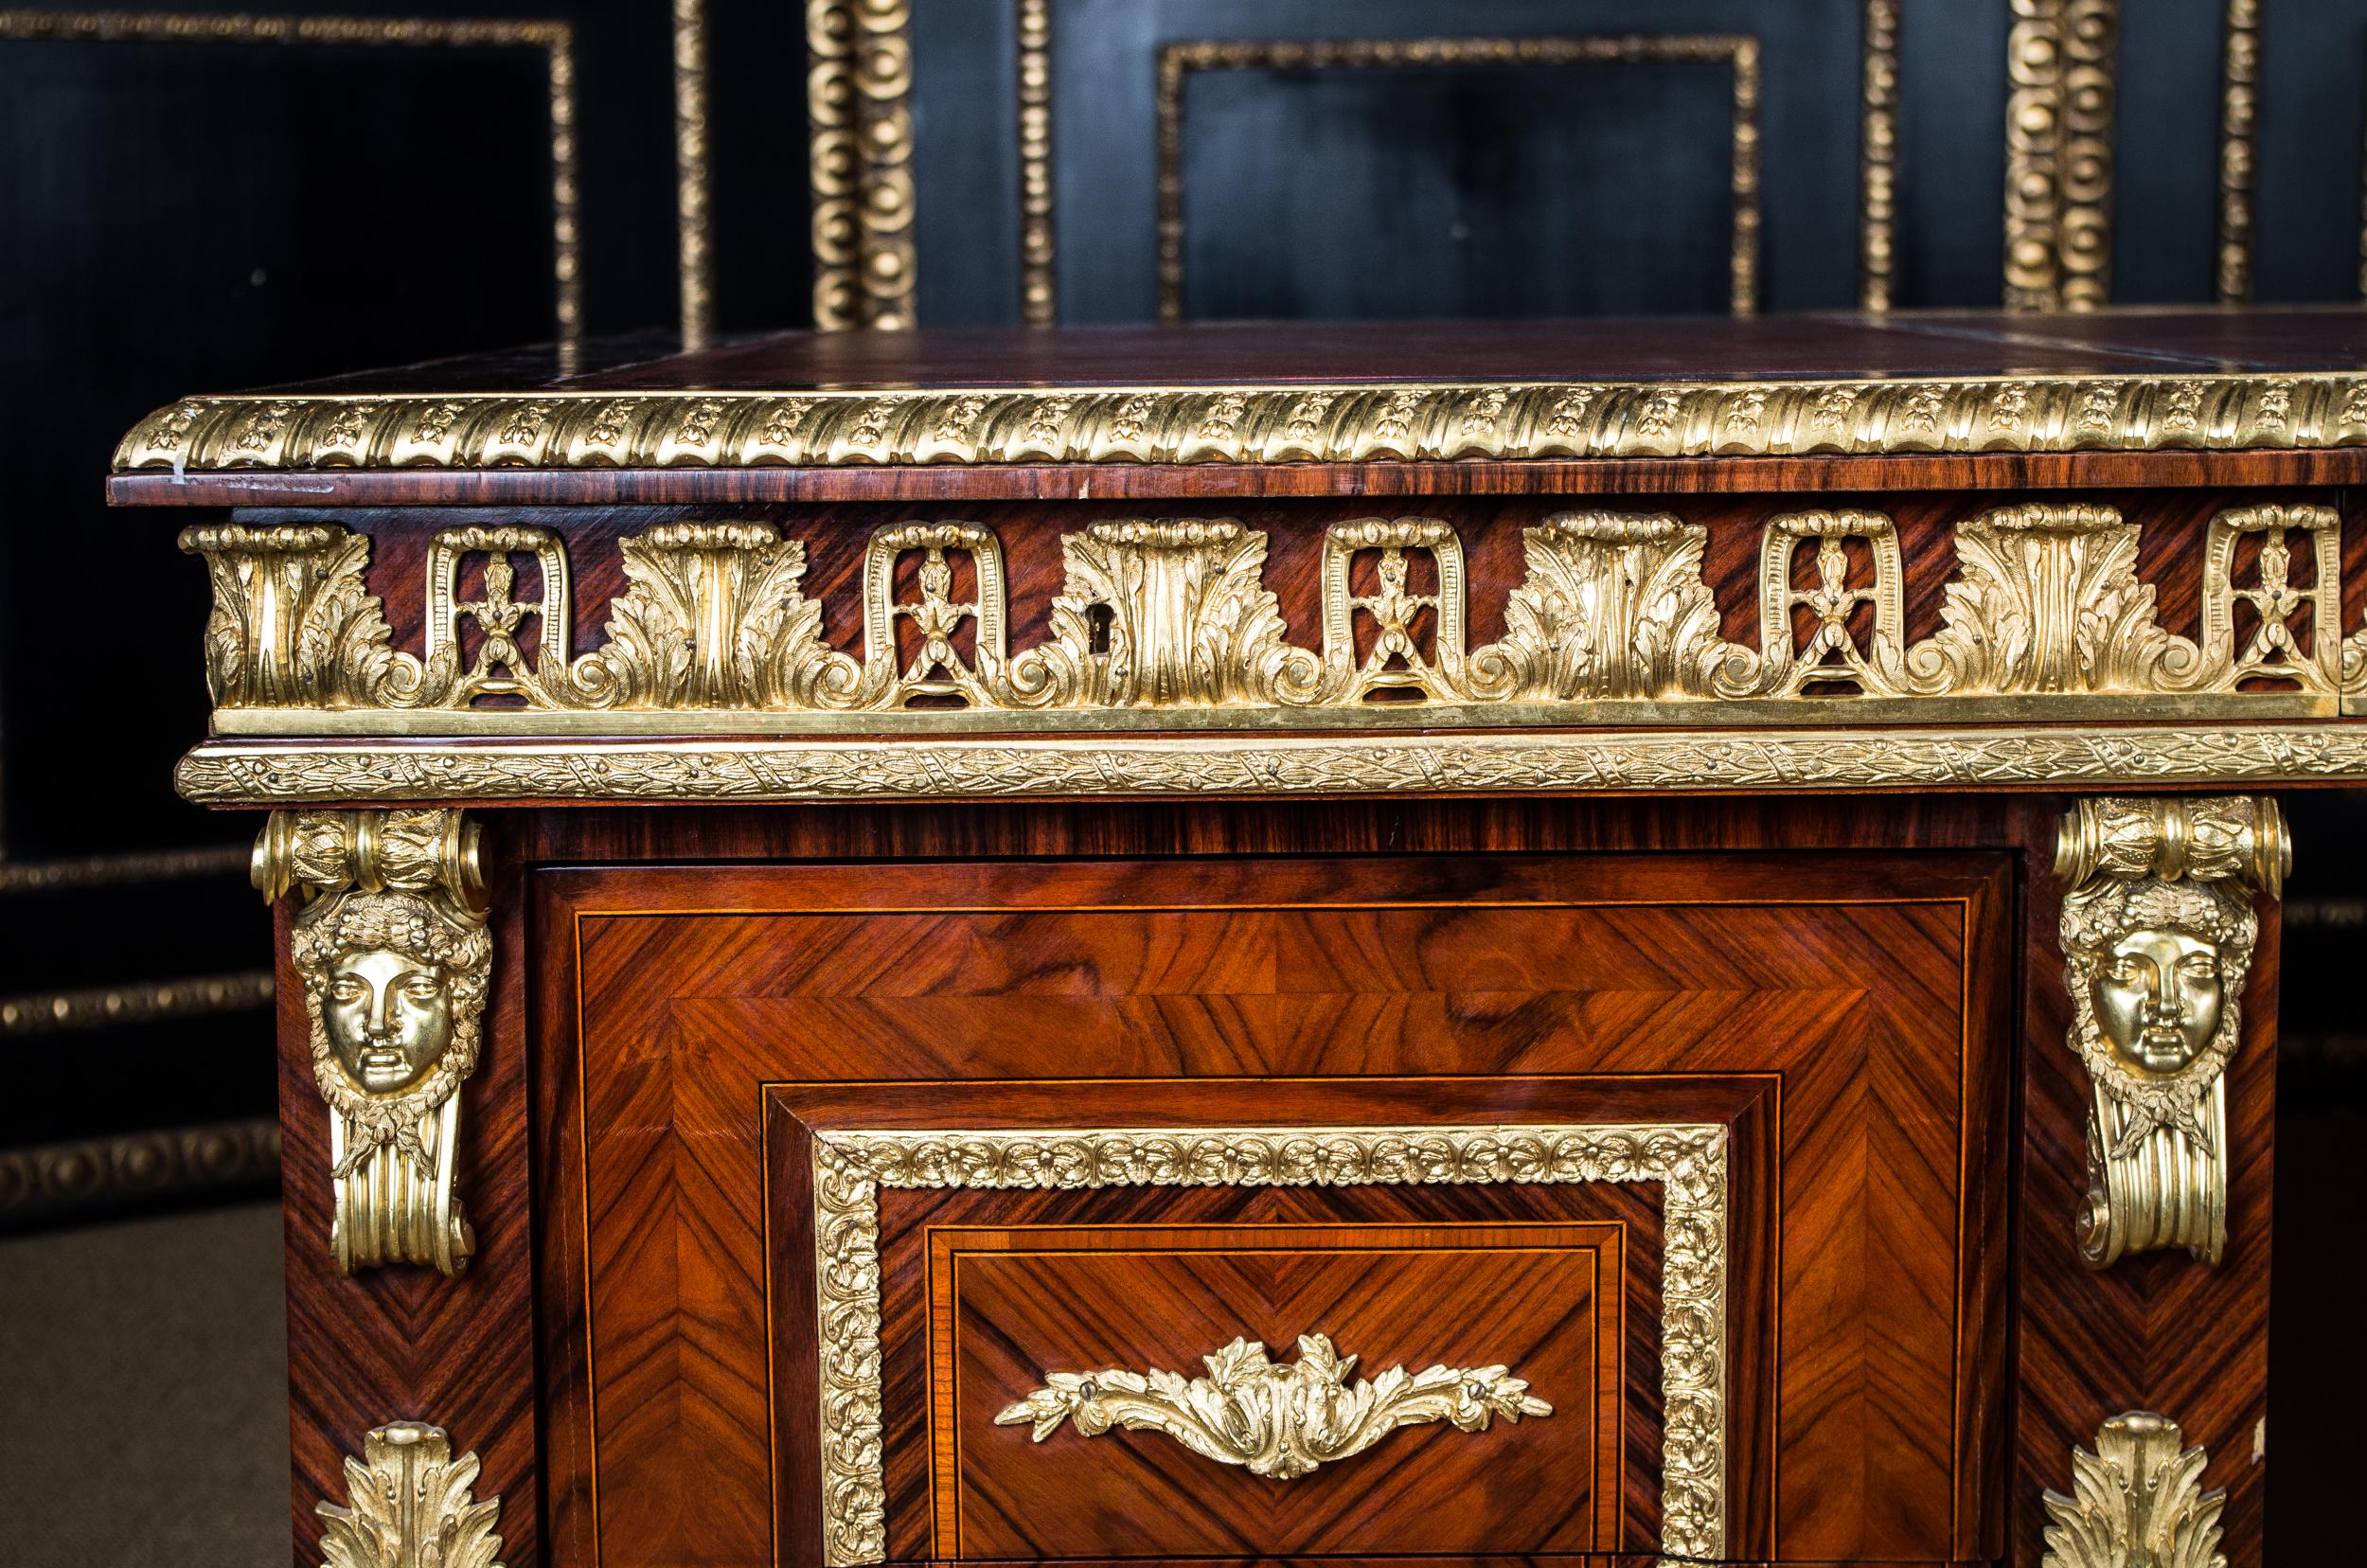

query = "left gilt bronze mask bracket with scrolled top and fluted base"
[[254, 811, 492, 1279]]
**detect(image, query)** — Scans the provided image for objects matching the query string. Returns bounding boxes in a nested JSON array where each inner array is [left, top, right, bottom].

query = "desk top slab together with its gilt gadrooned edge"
[[109, 308, 2367, 505]]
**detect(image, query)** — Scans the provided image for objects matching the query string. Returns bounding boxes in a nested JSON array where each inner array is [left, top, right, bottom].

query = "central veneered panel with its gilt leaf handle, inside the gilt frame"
[[918, 1191, 1628, 1559]]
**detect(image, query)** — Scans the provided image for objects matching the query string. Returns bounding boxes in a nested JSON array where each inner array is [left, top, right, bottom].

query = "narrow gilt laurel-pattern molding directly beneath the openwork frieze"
[[173, 724, 2367, 806]]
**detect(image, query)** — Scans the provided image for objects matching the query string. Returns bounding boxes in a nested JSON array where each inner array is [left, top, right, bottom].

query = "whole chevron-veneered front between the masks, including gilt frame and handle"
[[543, 855, 2010, 1568]]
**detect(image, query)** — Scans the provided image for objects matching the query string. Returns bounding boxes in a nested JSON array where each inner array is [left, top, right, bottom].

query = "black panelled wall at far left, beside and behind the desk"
[[0, 0, 808, 1207]]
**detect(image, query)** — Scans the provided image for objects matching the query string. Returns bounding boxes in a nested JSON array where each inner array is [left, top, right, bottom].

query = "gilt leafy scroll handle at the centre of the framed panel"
[[994, 1333, 1553, 1480]]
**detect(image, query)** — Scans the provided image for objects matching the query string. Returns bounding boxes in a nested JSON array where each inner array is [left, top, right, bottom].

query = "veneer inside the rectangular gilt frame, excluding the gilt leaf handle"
[[904, 1207, 1628, 1560]]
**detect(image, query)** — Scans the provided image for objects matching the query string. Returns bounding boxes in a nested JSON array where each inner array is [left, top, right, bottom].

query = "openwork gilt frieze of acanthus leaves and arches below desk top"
[[183, 502, 2367, 734]]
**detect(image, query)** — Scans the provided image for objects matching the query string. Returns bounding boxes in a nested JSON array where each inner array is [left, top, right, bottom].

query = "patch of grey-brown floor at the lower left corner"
[[0, 1199, 292, 1568]]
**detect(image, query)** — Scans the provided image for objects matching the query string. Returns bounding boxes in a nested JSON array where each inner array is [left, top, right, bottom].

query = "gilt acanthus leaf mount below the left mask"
[[312, 1421, 502, 1568]]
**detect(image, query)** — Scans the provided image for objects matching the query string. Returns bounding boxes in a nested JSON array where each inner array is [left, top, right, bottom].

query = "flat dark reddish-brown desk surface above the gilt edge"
[[225, 308, 2367, 396]]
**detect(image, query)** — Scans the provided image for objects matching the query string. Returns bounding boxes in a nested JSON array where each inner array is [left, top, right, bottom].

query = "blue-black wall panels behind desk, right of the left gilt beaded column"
[[914, 0, 2367, 322]]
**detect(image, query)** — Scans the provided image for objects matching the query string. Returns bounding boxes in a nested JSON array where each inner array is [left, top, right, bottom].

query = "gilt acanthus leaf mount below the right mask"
[[2040, 1409, 2228, 1568]]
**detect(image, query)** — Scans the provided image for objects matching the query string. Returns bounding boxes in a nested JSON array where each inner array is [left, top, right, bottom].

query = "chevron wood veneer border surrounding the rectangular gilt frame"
[[538, 855, 2005, 1563]]
